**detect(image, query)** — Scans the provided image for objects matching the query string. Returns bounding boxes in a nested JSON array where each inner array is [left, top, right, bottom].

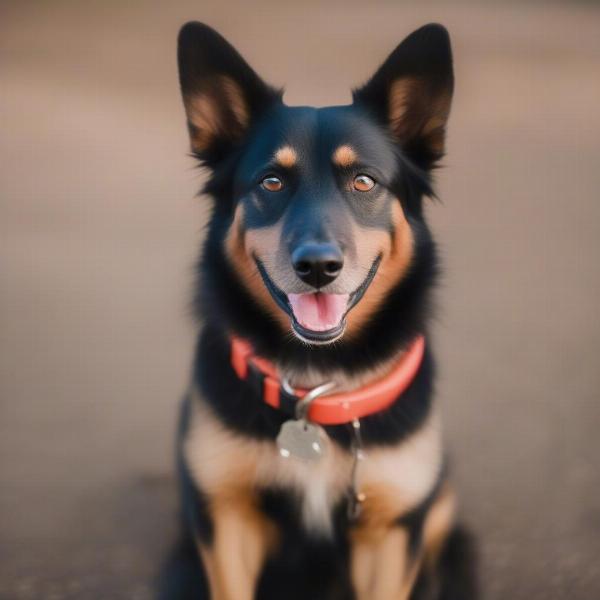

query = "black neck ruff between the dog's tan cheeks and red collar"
[[196, 213, 437, 380]]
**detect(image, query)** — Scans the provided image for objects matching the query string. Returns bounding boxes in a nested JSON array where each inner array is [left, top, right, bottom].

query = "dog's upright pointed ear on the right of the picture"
[[353, 24, 454, 168]]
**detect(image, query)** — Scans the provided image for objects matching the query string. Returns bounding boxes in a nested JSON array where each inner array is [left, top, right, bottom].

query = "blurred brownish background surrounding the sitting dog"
[[0, 0, 600, 600]]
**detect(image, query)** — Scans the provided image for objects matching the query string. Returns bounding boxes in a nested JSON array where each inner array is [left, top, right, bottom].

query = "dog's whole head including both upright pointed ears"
[[179, 23, 453, 344]]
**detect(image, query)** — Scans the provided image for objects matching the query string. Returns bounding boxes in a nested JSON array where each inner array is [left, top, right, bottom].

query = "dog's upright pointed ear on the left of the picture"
[[177, 22, 281, 165]]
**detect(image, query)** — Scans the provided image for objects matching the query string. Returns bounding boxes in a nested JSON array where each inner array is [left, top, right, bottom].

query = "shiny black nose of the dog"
[[292, 243, 344, 288]]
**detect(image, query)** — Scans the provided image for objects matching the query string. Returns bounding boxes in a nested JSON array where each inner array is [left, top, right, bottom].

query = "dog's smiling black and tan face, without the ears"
[[227, 106, 411, 343]]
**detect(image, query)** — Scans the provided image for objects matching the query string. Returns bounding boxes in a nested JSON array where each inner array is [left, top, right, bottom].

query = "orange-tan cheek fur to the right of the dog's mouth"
[[346, 202, 413, 336]]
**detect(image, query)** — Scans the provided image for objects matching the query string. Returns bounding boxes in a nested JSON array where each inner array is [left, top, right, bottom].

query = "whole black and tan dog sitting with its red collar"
[[163, 23, 473, 600]]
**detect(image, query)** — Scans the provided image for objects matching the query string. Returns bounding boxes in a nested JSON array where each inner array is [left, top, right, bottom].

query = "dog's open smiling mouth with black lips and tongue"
[[254, 255, 381, 344]]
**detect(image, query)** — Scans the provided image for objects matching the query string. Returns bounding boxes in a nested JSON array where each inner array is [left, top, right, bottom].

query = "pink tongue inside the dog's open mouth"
[[288, 292, 350, 331]]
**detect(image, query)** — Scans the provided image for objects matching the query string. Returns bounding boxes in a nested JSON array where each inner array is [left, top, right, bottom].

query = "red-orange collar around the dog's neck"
[[231, 335, 425, 425]]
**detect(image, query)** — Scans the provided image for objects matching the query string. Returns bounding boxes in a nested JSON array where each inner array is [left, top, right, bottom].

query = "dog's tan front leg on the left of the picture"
[[199, 500, 275, 600]]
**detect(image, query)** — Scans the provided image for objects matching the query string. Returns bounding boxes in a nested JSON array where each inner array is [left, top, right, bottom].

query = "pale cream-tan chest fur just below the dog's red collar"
[[184, 397, 441, 536]]
